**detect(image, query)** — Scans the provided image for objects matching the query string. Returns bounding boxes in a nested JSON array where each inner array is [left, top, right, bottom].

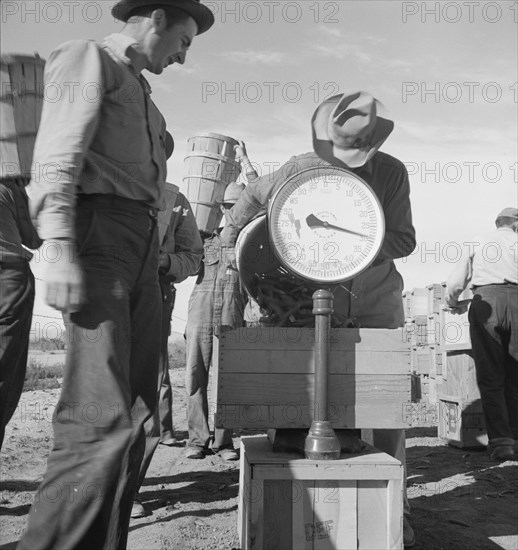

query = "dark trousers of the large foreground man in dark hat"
[[18, 195, 161, 550]]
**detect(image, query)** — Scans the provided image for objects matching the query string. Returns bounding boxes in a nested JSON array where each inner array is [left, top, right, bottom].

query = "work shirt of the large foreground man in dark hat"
[[29, 34, 167, 239]]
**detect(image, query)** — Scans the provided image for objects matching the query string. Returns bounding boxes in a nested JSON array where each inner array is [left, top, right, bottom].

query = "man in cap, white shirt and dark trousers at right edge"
[[445, 208, 518, 460]]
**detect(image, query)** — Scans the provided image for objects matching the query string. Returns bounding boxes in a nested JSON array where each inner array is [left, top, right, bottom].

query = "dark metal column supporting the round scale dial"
[[304, 289, 340, 460]]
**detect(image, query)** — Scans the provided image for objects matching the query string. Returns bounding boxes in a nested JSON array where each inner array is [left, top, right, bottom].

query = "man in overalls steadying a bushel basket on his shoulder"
[[185, 158, 253, 461]]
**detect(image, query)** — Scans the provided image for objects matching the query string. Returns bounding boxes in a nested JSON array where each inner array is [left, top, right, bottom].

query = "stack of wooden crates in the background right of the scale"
[[403, 283, 487, 447]]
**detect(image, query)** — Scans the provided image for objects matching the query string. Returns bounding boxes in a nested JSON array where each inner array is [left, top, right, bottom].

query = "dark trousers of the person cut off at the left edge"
[[0, 259, 34, 449]]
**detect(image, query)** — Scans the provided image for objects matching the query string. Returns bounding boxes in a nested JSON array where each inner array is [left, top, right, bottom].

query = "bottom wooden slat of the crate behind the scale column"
[[216, 373, 411, 429]]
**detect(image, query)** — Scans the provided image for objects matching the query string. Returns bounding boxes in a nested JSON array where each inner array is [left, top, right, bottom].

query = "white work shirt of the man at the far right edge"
[[446, 227, 518, 305]]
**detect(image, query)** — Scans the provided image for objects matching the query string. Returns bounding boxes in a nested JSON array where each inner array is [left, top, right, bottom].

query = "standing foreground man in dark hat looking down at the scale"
[[18, 0, 214, 550]]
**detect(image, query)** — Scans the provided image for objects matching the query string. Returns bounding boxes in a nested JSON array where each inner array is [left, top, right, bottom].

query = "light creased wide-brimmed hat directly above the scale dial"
[[311, 91, 394, 168]]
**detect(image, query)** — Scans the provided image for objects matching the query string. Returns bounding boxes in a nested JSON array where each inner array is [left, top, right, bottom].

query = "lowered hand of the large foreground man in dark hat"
[[43, 239, 86, 313]]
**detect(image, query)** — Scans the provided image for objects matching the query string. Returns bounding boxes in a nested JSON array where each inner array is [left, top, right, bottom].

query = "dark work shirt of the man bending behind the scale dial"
[[222, 151, 416, 328]]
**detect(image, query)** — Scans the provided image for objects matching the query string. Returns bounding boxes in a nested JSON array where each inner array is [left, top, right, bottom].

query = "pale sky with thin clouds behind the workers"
[[0, 0, 518, 337]]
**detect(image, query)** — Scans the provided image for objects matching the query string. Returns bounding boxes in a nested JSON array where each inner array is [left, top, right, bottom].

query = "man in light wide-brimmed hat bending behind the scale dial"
[[222, 91, 416, 547]]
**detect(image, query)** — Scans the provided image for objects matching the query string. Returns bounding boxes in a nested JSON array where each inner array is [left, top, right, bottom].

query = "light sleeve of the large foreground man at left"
[[28, 40, 104, 239]]
